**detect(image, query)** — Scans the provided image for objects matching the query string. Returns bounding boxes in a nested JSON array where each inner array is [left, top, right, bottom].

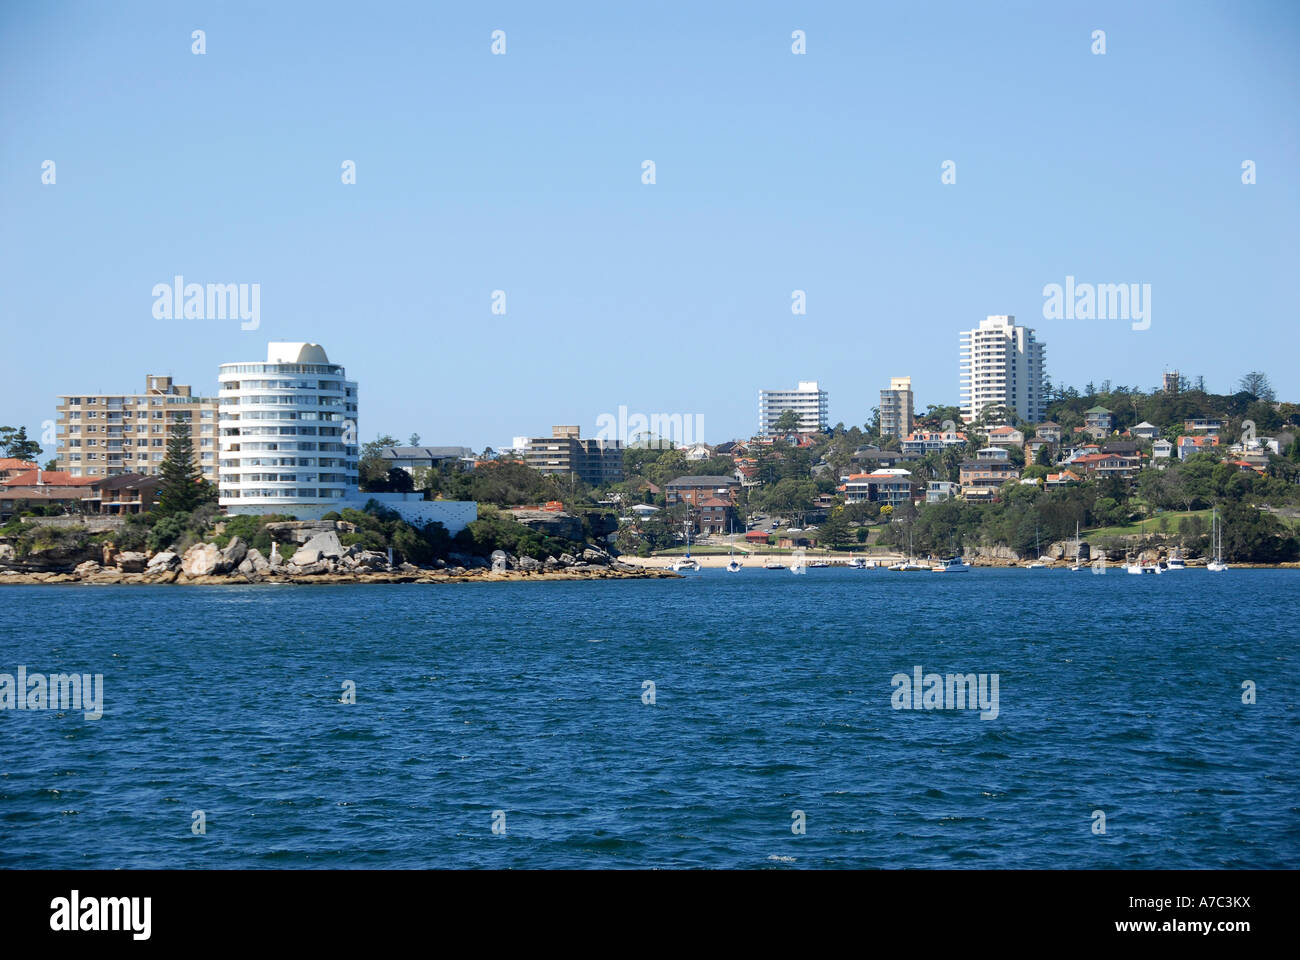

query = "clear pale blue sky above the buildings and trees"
[[0, 3, 1300, 455]]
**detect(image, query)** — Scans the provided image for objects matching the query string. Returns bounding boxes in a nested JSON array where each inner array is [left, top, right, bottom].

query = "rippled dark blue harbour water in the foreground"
[[0, 568, 1300, 869]]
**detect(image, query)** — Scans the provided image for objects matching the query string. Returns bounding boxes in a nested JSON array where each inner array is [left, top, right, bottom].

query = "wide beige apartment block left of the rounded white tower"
[[56, 376, 217, 483]]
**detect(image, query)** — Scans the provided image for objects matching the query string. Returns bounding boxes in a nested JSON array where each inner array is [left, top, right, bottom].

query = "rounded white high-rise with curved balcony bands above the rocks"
[[217, 343, 358, 519]]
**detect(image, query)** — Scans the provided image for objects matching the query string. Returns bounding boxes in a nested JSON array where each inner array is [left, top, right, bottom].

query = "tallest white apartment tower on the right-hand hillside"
[[961, 316, 1047, 424]]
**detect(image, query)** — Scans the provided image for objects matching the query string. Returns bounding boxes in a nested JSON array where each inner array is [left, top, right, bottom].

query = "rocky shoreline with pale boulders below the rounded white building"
[[0, 529, 679, 585]]
